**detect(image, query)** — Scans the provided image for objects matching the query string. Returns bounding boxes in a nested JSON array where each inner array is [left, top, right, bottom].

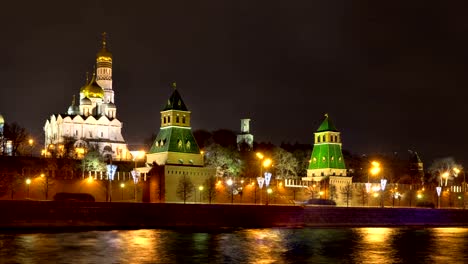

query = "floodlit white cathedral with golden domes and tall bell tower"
[[43, 33, 132, 160]]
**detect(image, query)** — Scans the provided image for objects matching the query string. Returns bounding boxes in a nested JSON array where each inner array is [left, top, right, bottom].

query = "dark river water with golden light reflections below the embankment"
[[0, 228, 468, 264]]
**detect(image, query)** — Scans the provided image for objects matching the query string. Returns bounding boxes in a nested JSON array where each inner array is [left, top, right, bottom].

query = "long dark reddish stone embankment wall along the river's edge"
[[0, 201, 468, 229]]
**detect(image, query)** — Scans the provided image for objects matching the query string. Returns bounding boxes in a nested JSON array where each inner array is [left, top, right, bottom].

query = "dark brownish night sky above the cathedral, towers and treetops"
[[0, 0, 468, 167]]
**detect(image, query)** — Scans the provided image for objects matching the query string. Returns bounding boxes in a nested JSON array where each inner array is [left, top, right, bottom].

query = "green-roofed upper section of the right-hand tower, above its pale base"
[[307, 114, 346, 177]]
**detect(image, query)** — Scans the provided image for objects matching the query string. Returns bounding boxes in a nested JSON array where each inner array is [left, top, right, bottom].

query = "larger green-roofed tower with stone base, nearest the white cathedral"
[[144, 83, 216, 202]]
